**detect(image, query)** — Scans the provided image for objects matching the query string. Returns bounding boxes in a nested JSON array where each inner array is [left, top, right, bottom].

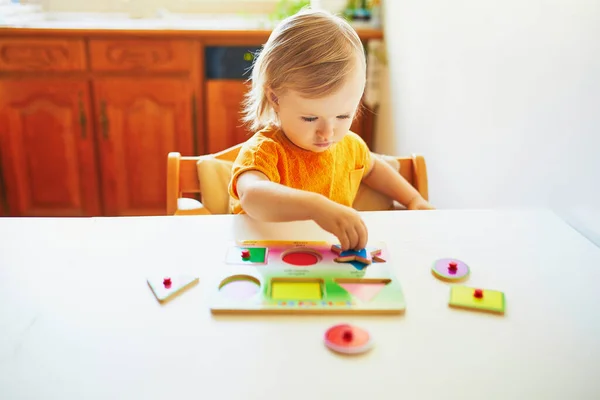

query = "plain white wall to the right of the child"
[[377, 0, 600, 217]]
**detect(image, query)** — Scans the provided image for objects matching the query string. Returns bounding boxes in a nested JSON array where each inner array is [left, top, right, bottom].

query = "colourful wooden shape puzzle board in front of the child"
[[211, 241, 406, 314]]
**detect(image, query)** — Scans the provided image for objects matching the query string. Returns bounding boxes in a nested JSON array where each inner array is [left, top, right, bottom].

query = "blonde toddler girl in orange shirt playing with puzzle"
[[229, 10, 432, 250]]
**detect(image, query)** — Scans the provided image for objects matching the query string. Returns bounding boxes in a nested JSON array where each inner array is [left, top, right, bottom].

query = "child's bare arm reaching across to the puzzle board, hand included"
[[237, 171, 368, 250]]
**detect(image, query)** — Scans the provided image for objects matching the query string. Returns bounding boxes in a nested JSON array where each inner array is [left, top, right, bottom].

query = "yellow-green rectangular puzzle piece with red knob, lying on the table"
[[448, 285, 506, 314]]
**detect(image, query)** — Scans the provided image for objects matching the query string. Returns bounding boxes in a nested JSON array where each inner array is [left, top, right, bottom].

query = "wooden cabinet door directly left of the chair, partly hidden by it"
[[95, 78, 196, 216]]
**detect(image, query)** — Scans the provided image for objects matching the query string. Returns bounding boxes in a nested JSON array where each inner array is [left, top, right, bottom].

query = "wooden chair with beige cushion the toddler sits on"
[[167, 143, 429, 215]]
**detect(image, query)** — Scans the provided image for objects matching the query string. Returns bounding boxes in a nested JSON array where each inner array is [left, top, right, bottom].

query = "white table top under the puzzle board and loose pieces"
[[0, 210, 600, 400]]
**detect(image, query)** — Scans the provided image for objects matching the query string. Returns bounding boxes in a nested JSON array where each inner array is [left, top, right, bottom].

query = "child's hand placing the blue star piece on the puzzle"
[[314, 198, 369, 251]]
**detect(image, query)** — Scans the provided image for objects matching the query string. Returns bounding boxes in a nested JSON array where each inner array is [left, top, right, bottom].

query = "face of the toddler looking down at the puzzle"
[[275, 68, 365, 152]]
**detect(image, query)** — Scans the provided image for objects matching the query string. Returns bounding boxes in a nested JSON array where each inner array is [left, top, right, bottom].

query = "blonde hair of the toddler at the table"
[[244, 9, 366, 130]]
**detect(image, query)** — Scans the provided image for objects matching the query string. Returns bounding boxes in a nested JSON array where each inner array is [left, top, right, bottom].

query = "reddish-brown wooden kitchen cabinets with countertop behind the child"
[[0, 28, 382, 217]]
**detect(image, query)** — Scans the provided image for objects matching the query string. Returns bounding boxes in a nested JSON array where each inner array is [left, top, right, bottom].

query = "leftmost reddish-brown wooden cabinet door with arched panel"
[[0, 78, 100, 217]]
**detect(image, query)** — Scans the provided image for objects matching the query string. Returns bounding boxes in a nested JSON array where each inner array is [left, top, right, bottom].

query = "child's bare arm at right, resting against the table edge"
[[363, 157, 434, 210]]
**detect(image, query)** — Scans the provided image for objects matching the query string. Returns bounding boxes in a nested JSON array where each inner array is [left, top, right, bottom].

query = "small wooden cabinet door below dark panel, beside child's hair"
[[205, 79, 252, 153]]
